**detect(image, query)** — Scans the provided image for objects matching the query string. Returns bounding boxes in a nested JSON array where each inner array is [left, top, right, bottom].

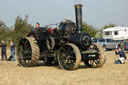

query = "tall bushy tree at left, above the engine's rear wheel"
[[12, 16, 33, 43]]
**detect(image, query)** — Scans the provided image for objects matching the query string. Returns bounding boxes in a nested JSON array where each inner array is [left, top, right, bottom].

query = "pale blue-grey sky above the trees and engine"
[[0, 0, 128, 28]]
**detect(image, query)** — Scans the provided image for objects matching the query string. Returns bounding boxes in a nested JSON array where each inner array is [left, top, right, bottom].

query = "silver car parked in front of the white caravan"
[[92, 39, 120, 50]]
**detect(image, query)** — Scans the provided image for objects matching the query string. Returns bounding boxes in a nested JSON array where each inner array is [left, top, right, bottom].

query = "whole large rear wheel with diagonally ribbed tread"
[[17, 37, 40, 67]]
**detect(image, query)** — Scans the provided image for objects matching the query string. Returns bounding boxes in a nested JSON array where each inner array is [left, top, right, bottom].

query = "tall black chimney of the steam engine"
[[74, 4, 82, 33]]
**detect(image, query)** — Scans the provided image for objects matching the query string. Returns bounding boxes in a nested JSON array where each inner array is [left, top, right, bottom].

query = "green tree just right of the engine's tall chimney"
[[83, 22, 97, 38]]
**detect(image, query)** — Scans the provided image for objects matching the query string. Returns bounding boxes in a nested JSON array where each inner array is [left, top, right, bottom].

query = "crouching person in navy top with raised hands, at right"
[[115, 48, 127, 64]]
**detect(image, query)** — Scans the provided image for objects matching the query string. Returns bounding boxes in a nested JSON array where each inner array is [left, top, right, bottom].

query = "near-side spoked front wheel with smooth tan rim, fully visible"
[[57, 43, 81, 70]]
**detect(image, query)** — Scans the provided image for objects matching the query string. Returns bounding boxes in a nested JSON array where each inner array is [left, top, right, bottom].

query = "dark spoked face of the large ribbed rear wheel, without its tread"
[[17, 39, 32, 67]]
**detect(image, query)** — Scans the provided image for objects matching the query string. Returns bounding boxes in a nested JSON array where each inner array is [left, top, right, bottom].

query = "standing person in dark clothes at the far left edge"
[[0, 40, 7, 61]]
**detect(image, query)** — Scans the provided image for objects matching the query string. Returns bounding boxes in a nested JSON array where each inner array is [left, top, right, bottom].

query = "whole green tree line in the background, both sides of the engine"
[[0, 16, 115, 43]]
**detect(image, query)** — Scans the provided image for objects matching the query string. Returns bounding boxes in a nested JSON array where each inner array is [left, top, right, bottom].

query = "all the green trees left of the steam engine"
[[0, 16, 33, 44]]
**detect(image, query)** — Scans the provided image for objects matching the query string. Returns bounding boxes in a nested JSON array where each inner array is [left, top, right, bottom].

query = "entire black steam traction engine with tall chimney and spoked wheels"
[[17, 4, 105, 70]]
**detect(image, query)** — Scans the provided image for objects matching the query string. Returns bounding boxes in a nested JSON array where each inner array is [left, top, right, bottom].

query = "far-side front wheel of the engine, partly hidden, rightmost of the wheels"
[[84, 43, 105, 68]]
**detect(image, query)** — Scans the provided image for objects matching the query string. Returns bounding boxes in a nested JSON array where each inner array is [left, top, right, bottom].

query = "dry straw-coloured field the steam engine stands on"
[[0, 51, 128, 85]]
